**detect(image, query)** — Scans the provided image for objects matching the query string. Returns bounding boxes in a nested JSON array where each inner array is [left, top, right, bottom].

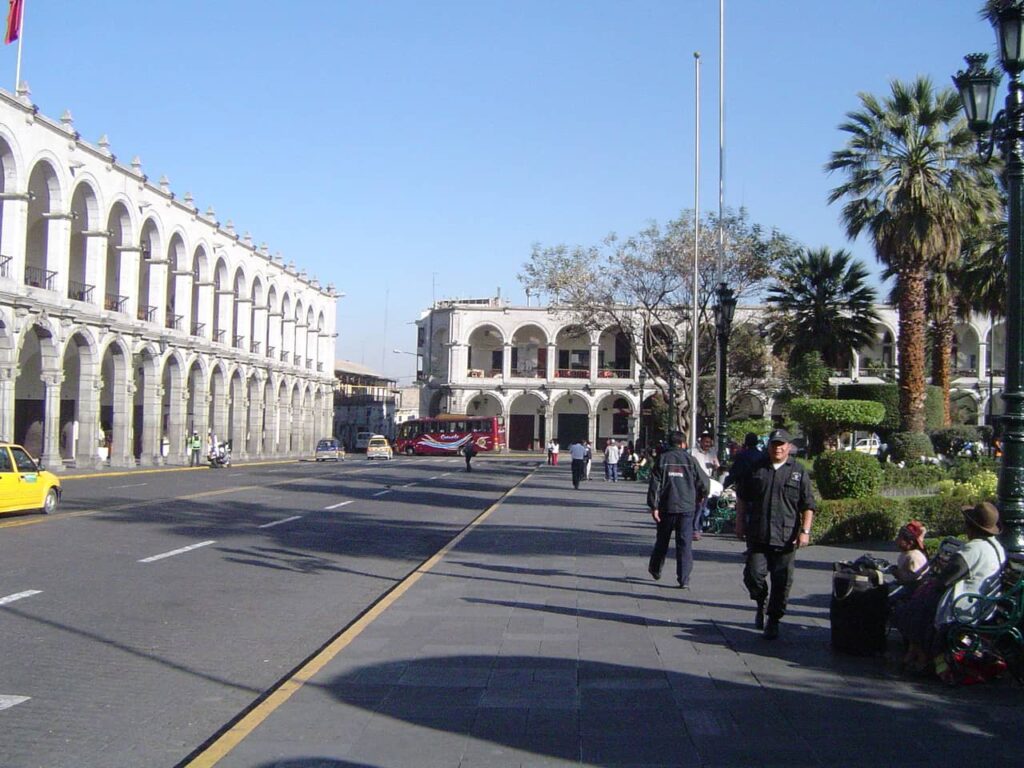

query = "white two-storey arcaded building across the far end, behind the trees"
[[417, 298, 1006, 451]]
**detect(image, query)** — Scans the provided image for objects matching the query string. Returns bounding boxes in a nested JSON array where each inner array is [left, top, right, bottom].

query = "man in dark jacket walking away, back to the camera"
[[647, 432, 708, 589]]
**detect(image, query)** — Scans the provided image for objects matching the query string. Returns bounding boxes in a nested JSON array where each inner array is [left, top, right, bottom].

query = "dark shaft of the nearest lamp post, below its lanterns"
[[999, 73, 1024, 552]]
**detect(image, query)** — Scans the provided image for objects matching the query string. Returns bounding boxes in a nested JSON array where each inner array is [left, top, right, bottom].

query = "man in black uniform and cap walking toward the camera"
[[736, 429, 817, 640]]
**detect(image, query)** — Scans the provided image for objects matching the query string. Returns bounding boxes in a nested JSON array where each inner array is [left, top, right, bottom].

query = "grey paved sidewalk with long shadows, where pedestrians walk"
[[209, 466, 1024, 768]]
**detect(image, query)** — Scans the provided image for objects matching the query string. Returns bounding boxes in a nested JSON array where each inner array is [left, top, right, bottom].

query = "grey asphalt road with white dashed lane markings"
[[0, 458, 538, 768]]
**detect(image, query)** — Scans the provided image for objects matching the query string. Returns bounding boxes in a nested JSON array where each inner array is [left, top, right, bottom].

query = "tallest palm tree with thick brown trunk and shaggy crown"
[[825, 77, 998, 432]]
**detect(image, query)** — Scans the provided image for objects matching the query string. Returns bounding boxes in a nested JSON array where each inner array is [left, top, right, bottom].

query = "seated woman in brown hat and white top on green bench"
[[894, 502, 1007, 672]]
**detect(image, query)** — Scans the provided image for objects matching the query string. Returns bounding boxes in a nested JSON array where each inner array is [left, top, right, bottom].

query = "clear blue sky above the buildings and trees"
[[8, 0, 994, 382]]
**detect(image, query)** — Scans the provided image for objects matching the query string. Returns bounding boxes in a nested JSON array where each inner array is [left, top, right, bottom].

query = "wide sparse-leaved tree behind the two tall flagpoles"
[[518, 209, 797, 436]]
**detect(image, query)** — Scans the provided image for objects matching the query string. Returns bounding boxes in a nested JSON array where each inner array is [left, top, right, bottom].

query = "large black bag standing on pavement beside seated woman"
[[828, 560, 889, 656]]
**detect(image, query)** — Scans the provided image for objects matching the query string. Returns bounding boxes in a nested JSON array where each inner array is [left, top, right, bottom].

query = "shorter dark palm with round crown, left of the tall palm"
[[765, 247, 879, 369]]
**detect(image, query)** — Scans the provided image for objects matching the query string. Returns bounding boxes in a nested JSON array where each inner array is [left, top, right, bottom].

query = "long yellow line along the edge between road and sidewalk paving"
[[182, 472, 532, 768]]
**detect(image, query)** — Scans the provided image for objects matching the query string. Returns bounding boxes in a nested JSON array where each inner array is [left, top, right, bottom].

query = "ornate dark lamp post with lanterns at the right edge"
[[953, 0, 1024, 552]]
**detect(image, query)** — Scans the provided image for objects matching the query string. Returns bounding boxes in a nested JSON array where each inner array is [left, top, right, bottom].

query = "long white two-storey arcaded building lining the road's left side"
[[0, 91, 337, 468]]
